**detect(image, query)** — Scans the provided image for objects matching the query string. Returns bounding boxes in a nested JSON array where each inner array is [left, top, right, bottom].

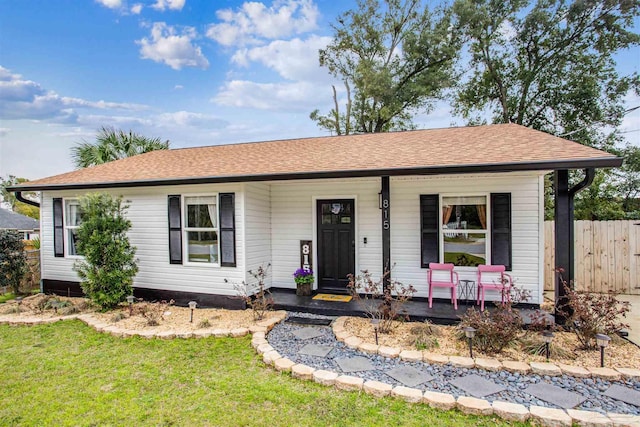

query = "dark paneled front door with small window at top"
[[317, 199, 356, 292]]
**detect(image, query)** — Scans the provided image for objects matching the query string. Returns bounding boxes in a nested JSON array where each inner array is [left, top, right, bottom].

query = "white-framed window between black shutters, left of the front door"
[[182, 194, 220, 265]]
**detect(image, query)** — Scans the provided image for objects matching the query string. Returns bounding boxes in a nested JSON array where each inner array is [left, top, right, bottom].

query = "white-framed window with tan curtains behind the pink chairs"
[[440, 194, 490, 267]]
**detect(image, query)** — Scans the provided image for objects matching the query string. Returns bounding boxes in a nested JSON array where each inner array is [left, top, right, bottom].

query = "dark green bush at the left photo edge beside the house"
[[0, 230, 28, 294]]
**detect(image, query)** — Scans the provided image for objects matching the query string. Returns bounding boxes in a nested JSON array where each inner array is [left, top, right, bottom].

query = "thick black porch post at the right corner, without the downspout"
[[553, 170, 573, 325]]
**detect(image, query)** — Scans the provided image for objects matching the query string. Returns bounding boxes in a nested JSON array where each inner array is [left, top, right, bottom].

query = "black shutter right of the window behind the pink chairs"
[[491, 193, 511, 270]]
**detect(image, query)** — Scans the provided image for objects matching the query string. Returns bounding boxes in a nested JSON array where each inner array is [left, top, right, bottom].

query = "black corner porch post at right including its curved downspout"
[[554, 168, 596, 325]]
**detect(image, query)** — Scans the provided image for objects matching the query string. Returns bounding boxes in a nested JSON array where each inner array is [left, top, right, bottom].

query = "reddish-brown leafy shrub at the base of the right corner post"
[[558, 271, 629, 349]]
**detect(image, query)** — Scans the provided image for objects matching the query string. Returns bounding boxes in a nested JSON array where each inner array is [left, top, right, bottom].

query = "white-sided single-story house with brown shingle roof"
[[13, 124, 621, 314]]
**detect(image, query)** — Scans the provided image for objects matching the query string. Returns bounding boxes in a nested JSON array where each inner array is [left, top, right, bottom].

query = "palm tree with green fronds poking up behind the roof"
[[71, 126, 169, 169]]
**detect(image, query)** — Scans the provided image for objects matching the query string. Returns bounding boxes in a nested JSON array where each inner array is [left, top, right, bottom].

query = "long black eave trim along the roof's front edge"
[[7, 156, 623, 191]]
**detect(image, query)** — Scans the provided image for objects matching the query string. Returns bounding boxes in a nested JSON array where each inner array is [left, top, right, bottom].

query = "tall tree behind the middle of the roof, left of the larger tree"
[[310, 0, 460, 135]]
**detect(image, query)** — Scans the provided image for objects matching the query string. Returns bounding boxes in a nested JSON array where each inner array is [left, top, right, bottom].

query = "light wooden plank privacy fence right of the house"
[[544, 220, 640, 295]]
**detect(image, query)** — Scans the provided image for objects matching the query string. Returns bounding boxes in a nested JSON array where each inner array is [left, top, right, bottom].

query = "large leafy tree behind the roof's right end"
[[454, 0, 640, 148]]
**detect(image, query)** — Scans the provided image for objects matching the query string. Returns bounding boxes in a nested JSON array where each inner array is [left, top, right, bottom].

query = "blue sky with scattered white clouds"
[[0, 0, 640, 179]]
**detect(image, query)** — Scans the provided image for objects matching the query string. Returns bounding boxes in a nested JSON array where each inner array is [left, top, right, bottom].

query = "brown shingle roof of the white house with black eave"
[[13, 124, 622, 191]]
